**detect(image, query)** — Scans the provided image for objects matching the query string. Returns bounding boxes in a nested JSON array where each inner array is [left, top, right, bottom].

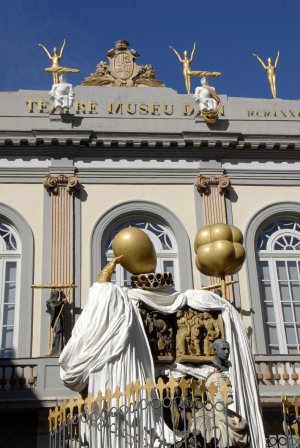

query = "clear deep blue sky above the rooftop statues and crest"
[[0, 0, 300, 99]]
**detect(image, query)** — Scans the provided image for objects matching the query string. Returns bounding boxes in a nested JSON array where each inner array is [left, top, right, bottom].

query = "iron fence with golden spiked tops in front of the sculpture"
[[49, 377, 300, 448]]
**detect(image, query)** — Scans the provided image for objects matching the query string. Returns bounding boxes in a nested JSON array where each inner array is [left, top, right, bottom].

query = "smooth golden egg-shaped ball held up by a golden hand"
[[112, 227, 156, 275]]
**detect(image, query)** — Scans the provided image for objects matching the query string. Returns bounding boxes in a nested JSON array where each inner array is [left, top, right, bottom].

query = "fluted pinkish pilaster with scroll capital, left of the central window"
[[43, 174, 81, 339]]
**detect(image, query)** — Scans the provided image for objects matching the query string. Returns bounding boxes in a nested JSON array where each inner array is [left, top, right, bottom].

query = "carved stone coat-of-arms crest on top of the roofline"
[[81, 40, 164, 87]]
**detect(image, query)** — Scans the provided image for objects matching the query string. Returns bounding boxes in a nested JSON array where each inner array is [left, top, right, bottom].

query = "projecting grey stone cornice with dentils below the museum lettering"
[[0, 130, 300, 156]]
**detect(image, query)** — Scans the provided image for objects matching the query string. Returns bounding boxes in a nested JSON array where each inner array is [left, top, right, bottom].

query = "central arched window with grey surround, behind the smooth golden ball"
[[91, 201, 193, 290]]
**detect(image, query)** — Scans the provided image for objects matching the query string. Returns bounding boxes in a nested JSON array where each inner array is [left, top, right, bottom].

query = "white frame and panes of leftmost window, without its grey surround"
[[0, 221, 21, 358]]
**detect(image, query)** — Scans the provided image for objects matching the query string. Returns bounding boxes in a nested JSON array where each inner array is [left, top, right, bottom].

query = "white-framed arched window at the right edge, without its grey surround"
[[257, 218, 300, 354]]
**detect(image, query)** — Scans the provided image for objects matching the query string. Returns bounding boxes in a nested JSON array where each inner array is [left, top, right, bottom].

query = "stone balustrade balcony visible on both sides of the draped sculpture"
[[0, 355, 300, 408]]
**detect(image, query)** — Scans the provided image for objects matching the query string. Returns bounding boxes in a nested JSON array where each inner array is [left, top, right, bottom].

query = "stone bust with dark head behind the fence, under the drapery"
[[191, 339, 250, 448]]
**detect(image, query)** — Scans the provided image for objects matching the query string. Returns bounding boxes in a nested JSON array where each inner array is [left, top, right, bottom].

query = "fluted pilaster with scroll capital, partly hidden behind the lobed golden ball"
[[196, 175, 233, 302]]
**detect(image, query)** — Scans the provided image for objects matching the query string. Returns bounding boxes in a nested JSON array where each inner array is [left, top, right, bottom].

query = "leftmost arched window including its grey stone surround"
[[0, 203, 34, 358]]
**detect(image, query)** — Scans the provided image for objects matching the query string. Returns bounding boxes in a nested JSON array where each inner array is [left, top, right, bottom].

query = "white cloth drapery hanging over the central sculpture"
[[59, 282, 265, 448]]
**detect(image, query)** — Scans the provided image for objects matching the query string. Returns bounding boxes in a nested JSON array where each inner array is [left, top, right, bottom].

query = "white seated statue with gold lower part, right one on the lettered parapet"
[[194, 77, 223, 124]]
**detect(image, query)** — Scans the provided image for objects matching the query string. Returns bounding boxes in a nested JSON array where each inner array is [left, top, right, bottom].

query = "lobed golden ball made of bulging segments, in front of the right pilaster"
[[194, 223, 245, 277]]
